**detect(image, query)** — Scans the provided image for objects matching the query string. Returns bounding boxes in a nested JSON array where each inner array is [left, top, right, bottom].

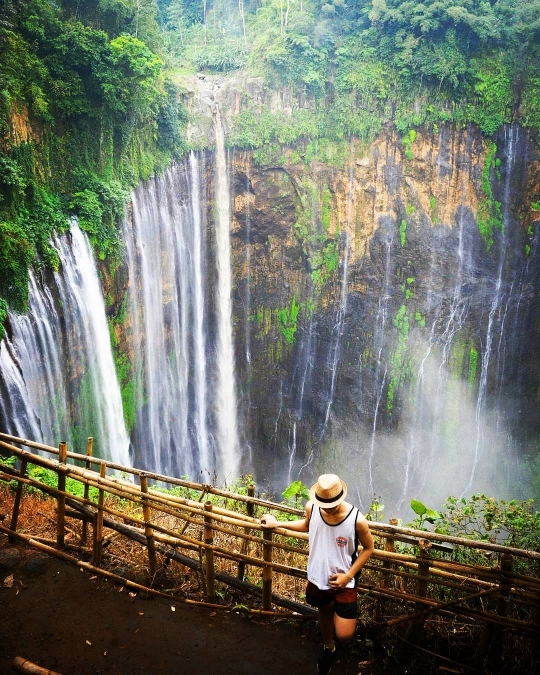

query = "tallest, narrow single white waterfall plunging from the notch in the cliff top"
[[214, 105, 239, 477]]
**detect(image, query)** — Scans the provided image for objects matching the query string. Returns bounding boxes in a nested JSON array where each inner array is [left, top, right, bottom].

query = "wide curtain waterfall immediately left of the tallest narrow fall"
[[123, 160, 214, 480]]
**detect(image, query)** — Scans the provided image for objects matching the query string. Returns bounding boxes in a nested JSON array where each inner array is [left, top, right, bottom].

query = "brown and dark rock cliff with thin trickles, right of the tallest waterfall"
[[221, 127, 540, 503]]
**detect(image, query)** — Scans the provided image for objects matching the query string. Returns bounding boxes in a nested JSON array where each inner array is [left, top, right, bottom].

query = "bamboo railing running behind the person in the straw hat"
[[0, 433, 540, 659]]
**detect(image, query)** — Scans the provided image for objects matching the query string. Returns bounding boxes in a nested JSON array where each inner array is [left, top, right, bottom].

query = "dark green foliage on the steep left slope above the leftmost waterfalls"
[[0, 0, 185, 318]]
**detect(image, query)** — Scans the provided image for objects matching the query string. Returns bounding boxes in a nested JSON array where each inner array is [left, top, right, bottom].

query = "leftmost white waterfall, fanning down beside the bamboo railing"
[[0, 224, 129, 465]]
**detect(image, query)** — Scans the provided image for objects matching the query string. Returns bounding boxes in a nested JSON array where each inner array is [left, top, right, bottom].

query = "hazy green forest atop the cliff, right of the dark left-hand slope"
[[192, 0, 540, 151]]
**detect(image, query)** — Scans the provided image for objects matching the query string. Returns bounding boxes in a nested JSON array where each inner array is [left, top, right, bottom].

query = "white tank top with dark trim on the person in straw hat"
[[307, 505, 358, 590]]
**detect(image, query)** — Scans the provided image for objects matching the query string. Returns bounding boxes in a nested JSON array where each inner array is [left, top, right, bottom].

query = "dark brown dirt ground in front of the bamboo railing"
[[0, 535, 392, 675]]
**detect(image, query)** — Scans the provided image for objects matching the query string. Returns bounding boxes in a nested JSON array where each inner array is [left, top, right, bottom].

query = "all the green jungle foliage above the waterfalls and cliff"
[[0, 0, 540, 328]]
